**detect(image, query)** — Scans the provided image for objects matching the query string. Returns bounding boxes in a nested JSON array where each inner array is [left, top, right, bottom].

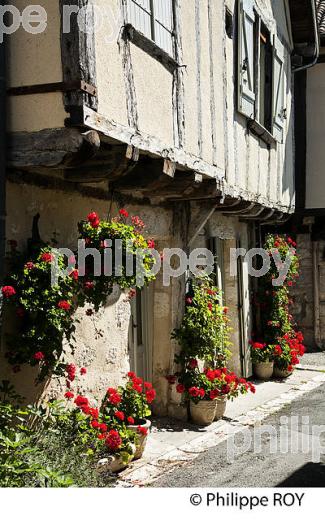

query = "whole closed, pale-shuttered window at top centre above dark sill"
[[128, 0, 174, 56]]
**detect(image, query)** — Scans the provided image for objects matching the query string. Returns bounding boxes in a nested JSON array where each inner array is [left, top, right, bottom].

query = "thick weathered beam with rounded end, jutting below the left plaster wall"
[[8, 128, 100, 169]]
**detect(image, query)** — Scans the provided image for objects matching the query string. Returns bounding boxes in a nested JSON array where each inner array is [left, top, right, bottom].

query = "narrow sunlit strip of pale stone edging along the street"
[[117, 373, 325, 487]]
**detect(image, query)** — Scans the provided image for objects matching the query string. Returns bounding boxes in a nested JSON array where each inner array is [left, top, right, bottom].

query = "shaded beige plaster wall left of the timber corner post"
[[7, 0, 66, 132]]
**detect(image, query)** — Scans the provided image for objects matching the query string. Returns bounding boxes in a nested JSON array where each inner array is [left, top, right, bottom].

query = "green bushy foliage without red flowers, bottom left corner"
[[0, 388, 116, 487]]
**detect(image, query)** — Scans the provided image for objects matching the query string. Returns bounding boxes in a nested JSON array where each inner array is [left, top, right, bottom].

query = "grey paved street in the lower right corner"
[[152, 385, 325, 487]]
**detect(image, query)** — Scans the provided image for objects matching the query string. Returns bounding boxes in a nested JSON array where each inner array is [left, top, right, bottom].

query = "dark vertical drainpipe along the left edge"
[[0, 26, 6, 314]]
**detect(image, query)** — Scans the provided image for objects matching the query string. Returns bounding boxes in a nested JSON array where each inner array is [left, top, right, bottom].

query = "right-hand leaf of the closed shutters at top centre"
[[153, 0, 174, 56]]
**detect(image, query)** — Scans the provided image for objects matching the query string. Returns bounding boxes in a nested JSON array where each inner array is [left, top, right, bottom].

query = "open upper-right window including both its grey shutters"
[[238, 0, 286, 142]]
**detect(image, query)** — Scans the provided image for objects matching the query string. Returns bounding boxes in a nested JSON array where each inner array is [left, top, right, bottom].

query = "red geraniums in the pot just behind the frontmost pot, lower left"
[[102, 372, 156, 460]]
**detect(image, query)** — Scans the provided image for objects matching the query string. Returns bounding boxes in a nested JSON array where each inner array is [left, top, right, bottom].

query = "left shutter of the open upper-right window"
[[238, 0, 255, 118]]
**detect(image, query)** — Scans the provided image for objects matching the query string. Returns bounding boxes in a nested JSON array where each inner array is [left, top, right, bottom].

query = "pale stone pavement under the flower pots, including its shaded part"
[[117, 369, 325, 487]]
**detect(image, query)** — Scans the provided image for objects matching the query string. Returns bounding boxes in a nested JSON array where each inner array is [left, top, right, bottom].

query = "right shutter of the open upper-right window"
[[272, 36, 286, 143]]
